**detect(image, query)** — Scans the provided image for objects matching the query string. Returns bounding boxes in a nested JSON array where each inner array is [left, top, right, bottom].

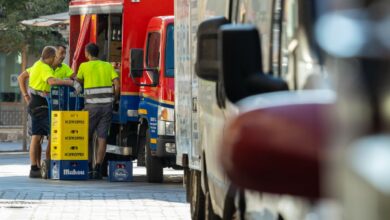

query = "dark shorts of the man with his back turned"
[[85, 104, 112, 138]]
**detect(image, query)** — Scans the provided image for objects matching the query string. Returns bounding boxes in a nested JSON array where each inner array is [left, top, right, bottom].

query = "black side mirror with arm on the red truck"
[[130, 48, 159, 87]]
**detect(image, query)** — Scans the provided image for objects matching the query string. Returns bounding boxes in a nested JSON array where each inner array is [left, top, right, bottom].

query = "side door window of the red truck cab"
[[146, 32, 160, 68]]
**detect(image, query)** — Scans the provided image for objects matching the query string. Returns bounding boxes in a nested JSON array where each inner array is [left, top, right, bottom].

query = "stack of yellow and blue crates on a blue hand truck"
[[49, 86, 89, 180]]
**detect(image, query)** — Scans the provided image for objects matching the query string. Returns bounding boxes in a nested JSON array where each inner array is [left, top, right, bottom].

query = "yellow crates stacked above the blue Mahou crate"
[[50, 111, 88, 160]]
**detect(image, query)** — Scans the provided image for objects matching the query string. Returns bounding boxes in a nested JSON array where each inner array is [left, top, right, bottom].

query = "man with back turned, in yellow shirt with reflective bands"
[[77, 43, 120, 179]]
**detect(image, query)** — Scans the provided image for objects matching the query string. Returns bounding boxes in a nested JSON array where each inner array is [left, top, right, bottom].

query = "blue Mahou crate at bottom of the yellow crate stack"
[[50, 160, 88, 180]]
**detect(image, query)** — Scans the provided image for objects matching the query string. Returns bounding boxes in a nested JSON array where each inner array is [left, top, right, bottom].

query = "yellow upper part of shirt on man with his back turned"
[[77, 60, 119, 89]]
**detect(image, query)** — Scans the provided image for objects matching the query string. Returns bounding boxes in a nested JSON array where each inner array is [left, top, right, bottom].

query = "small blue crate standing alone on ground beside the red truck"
[[107, 161, 133, 182]]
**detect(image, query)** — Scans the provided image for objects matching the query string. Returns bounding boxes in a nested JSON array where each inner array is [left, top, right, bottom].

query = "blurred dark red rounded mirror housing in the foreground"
[[221, 97, 331, 198]]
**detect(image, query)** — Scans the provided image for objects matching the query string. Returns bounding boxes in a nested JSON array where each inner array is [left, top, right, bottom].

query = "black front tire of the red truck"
[[145, 129, 164, 183]]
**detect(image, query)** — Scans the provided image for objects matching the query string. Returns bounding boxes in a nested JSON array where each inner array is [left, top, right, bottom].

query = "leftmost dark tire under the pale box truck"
[[190, 170, 205, 220]]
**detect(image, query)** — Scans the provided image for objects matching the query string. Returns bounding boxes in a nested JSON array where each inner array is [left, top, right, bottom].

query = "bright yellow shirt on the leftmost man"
[[27, 60, 55, 92]]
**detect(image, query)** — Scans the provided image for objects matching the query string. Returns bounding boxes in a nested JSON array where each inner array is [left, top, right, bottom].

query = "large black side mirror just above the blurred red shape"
[[219, 24, 288, 102]]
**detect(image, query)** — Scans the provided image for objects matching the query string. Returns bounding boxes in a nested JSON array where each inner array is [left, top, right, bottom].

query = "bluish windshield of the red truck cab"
[[165, 24, 175, 77]]
